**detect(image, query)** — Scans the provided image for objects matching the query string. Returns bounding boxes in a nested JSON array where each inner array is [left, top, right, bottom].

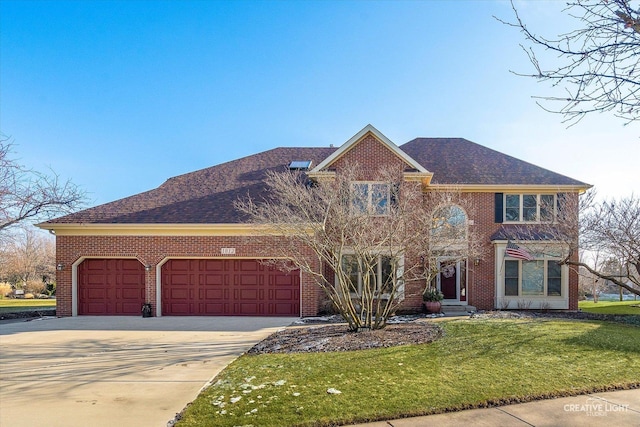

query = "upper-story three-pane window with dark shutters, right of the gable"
[[504, 194, 556, 222]]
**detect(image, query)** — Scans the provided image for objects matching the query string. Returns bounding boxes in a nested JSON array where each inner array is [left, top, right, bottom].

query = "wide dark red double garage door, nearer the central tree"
[[161, 259, 300, 316]]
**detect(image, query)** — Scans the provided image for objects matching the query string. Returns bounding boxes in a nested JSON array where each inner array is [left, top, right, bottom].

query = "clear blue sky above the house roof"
[[0, 0, 640, 205]]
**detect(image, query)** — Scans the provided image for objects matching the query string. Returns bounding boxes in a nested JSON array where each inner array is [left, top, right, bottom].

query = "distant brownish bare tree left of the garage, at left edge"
[[0, 227, 56, 294]]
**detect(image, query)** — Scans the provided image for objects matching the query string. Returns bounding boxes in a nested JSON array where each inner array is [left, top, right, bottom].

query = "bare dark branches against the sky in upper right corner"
[[498, 0, 640, 124]]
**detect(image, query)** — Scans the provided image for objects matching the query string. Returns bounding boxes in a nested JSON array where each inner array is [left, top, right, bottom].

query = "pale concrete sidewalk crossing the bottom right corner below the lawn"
[[355, 389, 640, 427]]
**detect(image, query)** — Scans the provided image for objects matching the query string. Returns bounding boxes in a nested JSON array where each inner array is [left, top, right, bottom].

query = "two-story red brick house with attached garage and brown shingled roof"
[[38, 125, 590, 316]]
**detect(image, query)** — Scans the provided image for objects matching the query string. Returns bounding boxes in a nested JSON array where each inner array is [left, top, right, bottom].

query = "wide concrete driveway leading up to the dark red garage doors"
[[0, 316, 295, 427]]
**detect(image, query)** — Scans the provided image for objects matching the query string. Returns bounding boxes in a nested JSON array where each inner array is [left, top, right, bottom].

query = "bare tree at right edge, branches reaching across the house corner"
[[511, 191, 640, 295]]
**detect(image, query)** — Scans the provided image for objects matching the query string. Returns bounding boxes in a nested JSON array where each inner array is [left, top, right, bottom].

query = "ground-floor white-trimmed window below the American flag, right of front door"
[[503, 259, 562, 297]]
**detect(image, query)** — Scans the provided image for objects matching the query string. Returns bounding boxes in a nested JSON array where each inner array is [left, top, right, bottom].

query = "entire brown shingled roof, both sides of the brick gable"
[[42, 138, 588, 228]]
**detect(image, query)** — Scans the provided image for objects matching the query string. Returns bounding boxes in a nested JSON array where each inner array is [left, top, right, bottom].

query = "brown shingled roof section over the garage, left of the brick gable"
[[45, 147, 336, 224]]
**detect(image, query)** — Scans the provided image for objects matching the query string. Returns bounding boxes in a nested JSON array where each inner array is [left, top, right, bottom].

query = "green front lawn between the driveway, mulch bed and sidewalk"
[[177, 319, 640, 427]]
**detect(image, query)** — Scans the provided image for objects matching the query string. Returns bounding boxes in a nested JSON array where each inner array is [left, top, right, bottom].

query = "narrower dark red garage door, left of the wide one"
[[78, 259, 145, 316]]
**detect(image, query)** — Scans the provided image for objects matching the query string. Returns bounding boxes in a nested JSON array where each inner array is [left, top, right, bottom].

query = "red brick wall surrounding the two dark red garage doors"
[[56, 236, 321, 316]]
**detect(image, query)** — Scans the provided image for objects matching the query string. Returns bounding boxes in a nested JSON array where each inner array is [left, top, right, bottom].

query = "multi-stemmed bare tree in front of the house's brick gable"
[[236, 165, 481, 330]]
